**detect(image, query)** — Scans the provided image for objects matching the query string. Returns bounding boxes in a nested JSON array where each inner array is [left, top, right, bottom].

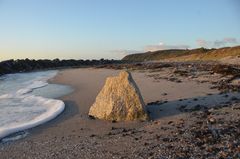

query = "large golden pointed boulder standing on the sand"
[[89, 71, 148, 121]]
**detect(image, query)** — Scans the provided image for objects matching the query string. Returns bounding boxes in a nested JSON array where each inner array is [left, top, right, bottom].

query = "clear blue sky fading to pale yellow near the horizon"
[[0, 0, 240, 60]]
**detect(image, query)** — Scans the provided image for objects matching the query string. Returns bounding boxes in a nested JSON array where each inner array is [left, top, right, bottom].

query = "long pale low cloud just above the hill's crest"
[[144, 42, 190, 51]]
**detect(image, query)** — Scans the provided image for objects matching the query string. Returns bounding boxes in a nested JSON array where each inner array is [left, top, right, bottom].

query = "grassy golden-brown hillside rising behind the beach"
[[123, 46, 240, 61]]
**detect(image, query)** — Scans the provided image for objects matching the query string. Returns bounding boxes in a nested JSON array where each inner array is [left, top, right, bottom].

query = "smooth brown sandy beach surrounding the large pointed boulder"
[[0, 68, 239, 159]]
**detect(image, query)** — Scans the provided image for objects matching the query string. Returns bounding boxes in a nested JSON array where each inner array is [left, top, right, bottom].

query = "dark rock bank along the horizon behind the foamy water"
[[0, 59, 121, 75]]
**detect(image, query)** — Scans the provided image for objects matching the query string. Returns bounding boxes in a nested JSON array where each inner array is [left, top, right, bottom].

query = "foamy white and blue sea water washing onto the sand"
[[0, 71, 72, 140]]
